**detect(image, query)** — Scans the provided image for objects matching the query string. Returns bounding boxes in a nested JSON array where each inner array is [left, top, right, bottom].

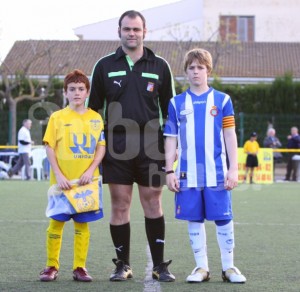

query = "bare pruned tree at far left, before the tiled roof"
[[0, 41, 68, 145]]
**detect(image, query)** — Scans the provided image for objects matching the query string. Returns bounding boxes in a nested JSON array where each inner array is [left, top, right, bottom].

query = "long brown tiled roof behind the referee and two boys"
[[2, 40, 300, 79]]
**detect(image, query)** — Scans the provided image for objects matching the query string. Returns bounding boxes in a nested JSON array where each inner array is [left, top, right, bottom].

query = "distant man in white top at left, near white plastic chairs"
[[7, 119, 34, 180]]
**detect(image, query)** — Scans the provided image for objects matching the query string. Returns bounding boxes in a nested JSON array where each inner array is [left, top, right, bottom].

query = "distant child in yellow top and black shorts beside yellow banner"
[[244, 132, 259, 184]]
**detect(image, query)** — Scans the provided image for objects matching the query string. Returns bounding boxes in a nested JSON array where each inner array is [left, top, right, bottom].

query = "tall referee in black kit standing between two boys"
[[88, 10, 175, 282]]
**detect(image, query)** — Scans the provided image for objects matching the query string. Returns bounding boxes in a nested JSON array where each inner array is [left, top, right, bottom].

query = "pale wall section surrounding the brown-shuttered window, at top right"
[[203, 0, 300, 42]]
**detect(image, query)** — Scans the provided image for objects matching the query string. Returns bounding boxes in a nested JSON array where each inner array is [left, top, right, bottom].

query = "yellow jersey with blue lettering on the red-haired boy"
[[43, 107, 105, 185]]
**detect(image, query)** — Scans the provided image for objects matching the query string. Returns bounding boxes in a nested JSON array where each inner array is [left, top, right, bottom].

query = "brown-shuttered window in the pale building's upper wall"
[[219, 15, 254, 42]]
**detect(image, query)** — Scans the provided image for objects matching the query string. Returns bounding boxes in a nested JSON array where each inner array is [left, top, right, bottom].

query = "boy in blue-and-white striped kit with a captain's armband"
[[164, 48, 246, 283]]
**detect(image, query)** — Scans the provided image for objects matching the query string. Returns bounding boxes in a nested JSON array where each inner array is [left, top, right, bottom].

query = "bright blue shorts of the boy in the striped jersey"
[[175, 185, 233, 221]]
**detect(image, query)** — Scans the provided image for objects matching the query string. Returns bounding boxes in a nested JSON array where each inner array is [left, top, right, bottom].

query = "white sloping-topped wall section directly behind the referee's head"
[[74, 0, 204, 41]]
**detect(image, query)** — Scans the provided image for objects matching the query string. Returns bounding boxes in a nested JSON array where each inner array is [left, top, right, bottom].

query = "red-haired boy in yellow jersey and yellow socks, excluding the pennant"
[[40, 70, 105, 282]]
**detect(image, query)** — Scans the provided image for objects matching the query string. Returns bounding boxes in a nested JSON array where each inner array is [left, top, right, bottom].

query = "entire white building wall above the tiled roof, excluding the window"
[[74, 0, 300, 42]]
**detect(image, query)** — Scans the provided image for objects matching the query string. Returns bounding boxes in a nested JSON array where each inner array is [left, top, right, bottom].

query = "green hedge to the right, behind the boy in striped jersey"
[[173, 73, 300, 148]]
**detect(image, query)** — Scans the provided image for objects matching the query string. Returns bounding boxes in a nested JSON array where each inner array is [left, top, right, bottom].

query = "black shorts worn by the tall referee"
[[102, 131, 165, 187]]
